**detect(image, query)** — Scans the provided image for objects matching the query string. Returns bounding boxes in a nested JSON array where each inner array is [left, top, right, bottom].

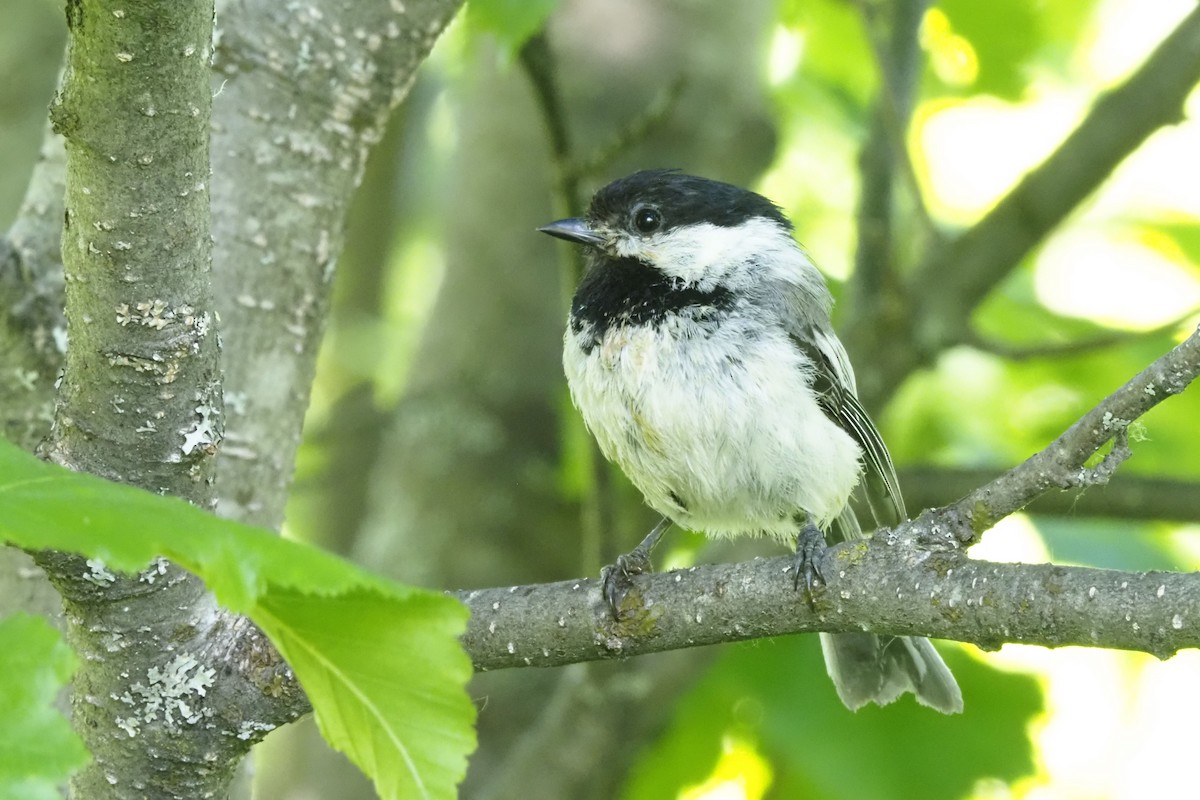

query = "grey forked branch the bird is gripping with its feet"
[[457, 331, 1200, 669]]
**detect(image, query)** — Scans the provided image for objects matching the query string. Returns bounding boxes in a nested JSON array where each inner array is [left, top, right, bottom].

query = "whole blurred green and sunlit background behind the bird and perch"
[[0, 0, 1200, 800]]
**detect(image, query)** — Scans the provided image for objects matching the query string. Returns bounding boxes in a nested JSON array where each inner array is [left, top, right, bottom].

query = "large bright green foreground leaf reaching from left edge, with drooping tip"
[[0, 440, 474, 798]]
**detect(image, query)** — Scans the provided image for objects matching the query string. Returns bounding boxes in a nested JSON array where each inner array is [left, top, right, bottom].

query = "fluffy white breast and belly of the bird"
[[563, 313, 862, 537]]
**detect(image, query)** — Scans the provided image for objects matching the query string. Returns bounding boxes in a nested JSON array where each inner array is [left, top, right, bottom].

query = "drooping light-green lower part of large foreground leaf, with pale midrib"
[[260, 589, 474, 798]]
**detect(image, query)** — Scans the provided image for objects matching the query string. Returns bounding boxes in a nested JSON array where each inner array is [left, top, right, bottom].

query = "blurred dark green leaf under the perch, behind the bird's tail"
[[622, 637, 1042, 800]]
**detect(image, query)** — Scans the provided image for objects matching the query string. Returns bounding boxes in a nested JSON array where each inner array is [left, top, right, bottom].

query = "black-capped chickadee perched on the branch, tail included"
[[539, 170, 962, 714]]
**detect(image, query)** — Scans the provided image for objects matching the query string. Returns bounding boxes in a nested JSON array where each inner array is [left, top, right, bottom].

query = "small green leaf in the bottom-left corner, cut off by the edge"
[[0, 614, 88, 800]]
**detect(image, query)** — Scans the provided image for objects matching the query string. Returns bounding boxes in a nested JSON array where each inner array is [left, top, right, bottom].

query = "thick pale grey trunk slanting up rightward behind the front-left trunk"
[[212, 0, 462, 529]]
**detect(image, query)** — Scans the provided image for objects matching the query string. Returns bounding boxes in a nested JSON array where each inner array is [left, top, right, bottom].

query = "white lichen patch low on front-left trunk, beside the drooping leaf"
[[115, 654, 217, 736]]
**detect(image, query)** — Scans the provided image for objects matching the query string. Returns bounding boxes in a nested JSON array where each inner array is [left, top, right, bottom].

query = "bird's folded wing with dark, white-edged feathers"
[[790, 325, 908, 524]]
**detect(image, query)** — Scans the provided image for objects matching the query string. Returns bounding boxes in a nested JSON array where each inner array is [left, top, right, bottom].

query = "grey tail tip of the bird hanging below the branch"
[[821, 633, 962, 714]]
